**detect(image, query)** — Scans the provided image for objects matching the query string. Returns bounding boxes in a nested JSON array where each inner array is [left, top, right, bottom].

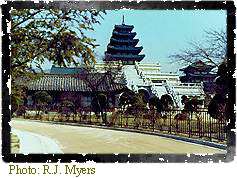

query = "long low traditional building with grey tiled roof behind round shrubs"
[[21, 66, 126, 110]]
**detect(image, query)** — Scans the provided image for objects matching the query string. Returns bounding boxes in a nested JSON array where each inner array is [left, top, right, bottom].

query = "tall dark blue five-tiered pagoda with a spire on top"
[[105, 17, 145, 65]]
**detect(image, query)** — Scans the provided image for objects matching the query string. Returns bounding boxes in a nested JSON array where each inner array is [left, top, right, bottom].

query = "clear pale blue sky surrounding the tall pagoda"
[[42, 9, 226, 72]]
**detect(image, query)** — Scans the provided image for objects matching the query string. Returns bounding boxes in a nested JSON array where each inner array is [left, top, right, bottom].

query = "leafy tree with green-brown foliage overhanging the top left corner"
[[11, 9, 102, 113]]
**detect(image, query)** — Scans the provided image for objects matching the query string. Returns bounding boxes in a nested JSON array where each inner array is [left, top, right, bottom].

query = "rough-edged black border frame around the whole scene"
[[2, 1, 236, 163]]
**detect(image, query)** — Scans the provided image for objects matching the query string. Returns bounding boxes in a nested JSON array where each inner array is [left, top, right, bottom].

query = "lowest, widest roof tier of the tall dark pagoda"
[[105, 53, 145, 62]]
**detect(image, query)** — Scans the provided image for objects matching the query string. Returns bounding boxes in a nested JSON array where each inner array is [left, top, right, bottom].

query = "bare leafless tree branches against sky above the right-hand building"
[[169, 30, 227, 67]]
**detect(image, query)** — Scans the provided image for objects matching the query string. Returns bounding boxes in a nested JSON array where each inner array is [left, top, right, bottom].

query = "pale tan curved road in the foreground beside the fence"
[[11, 119, 225, 154]]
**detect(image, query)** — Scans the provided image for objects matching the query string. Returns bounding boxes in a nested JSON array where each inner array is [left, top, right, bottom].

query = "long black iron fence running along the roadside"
[[23, 110, 227, 143]]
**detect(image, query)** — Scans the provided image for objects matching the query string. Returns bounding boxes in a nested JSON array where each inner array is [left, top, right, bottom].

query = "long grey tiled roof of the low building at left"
[[27, 74, 126, 92]]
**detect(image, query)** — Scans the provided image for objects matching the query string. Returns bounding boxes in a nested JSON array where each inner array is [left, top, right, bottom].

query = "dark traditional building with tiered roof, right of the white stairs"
[[180, 60, 217, 93]]
